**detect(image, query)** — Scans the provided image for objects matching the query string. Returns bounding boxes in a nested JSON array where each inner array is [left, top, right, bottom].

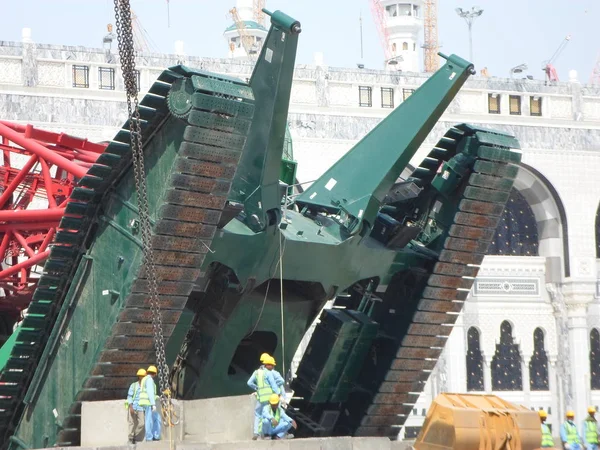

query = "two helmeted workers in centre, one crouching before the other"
[[248, 353, 298, 440]]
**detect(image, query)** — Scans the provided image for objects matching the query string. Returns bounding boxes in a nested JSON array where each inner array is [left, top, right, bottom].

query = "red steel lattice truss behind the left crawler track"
[[0, 121, 106, 316]]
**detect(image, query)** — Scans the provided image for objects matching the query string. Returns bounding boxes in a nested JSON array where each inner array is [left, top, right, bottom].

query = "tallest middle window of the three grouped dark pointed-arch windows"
[[492, 320, 523, 391]]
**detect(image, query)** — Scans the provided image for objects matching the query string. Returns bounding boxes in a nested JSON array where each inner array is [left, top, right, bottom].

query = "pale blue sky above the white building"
[[0, 0, 600, 83]]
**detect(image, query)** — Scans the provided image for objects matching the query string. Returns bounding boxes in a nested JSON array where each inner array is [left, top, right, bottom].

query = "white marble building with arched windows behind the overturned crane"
[[0, 21, 600, 436]]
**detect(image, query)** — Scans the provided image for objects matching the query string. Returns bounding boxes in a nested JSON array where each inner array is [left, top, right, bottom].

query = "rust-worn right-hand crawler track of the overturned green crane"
[[355, 125, 520, 437]]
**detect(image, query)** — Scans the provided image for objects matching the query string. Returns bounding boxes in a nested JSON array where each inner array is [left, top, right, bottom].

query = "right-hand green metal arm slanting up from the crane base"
[[298, 55, 474, 230]]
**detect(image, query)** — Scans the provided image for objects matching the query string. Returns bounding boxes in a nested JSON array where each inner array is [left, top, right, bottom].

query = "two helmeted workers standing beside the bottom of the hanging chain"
[[125, 366, 161, 444]]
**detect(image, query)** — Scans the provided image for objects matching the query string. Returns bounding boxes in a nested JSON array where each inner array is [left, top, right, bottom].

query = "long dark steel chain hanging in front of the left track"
[[114, 0, 171, 409]]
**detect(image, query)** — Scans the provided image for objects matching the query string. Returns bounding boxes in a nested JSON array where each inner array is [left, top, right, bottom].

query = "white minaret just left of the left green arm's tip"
[[223, 0, 268, 59]]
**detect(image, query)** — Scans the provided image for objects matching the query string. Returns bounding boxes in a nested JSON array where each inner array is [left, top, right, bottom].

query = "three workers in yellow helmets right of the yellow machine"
[[539, 406, 599, 450]]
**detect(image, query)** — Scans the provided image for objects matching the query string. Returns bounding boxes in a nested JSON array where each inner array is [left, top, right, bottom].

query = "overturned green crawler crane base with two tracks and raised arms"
[[0, 7, 520, 449]]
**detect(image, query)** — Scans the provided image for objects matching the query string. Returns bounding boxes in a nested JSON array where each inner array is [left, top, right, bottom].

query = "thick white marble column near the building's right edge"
[[565, 303, 590, 420]]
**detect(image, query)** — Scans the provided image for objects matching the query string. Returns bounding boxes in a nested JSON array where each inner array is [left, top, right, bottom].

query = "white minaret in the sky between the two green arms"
[[380, 0, 423, 72]]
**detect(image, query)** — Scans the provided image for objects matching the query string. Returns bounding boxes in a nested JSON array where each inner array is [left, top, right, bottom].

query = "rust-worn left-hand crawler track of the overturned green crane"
[[0, 66, 254, 448]]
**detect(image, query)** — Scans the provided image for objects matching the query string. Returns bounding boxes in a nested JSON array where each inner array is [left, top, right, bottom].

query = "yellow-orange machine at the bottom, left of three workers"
[[414, 394, 542, 450]]
